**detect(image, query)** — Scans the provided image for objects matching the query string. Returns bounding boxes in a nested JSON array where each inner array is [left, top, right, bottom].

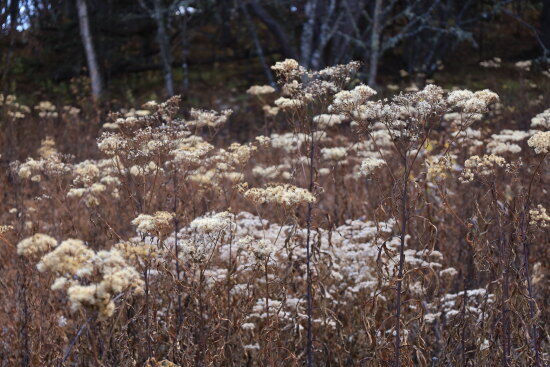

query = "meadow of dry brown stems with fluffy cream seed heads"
[[0, 59, 550, 367]]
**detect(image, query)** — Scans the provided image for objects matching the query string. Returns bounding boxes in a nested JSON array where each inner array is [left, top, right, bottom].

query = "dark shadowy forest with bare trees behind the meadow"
[[0, 0, 550, 108]]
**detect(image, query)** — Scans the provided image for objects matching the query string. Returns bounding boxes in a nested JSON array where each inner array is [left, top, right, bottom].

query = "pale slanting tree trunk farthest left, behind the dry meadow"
[[76, 0, 103, 100]]
